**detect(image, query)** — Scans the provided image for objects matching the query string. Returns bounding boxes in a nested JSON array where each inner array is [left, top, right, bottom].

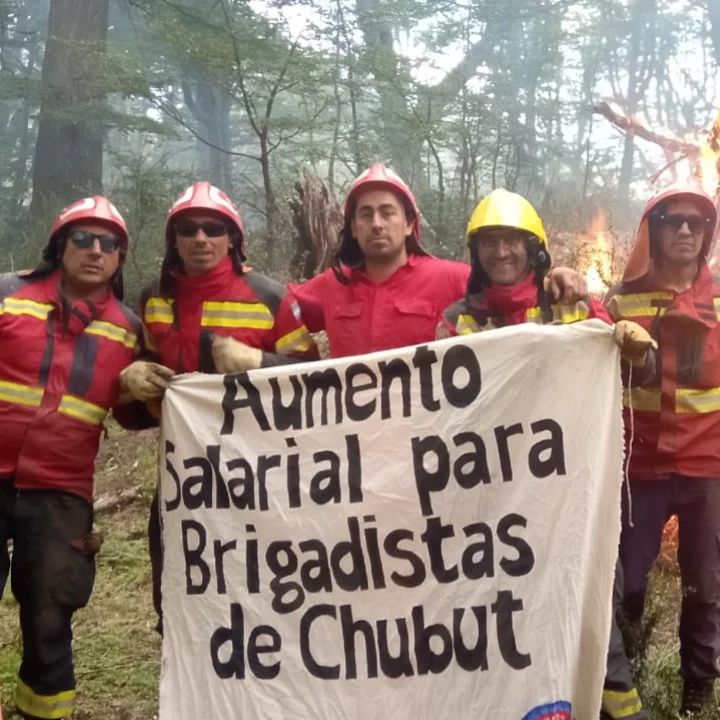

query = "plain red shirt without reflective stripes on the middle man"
[[290, 255, 470, 357]]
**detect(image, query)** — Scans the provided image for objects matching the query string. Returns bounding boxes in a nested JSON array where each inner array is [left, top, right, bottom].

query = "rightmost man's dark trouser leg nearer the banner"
[[620, 478, 672, 628]]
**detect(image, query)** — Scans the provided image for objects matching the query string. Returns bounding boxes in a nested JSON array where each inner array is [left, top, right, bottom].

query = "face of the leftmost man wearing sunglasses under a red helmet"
[[62, 222, 121, 297]]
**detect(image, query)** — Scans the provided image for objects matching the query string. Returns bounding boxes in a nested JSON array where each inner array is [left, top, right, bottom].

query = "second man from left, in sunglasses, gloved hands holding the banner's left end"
[[122, 181, 318, 631]]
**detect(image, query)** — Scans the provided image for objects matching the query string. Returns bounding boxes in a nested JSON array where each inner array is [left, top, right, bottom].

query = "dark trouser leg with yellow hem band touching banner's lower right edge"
[[602, 559, 647, 720]]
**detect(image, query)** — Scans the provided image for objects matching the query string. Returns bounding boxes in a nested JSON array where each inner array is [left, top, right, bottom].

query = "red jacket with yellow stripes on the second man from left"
[[142, 257, 317, 372]]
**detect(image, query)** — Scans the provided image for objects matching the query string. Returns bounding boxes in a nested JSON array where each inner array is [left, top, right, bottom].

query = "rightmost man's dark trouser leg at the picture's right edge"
[[674, 476, 720, 680]]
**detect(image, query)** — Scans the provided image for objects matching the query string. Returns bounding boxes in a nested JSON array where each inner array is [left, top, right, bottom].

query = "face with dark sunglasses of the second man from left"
[[174, 213, 231, 277]]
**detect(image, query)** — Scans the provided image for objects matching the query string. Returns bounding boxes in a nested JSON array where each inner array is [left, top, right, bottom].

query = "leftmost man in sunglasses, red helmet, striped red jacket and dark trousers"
[[0, 196, 145, 718]]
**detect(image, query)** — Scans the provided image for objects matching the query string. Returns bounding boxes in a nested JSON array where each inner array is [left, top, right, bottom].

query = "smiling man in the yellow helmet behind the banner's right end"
[[437, 189, 652, 720]]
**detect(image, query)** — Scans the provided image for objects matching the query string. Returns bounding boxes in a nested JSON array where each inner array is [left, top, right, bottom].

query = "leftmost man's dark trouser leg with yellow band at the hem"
[[11, 490, 95, 718]]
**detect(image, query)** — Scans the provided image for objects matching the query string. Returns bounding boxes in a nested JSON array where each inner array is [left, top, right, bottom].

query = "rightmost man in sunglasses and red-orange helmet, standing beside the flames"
[[608, 186, 720, 715]]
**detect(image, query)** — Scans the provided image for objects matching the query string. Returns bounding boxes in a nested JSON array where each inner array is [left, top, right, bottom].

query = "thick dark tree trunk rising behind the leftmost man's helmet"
[[30, 0, 108, 229]]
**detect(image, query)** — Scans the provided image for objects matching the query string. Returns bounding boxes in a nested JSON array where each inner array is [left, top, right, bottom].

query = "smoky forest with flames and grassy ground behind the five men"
[[0, 0, 720, 720]]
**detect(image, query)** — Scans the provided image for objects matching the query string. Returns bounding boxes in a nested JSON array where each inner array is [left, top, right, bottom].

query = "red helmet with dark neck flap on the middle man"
[[338, 163, 427, 266]]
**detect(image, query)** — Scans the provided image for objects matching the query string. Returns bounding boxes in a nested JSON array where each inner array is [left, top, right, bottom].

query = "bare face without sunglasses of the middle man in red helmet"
[[350, 190, 412, 265]]
